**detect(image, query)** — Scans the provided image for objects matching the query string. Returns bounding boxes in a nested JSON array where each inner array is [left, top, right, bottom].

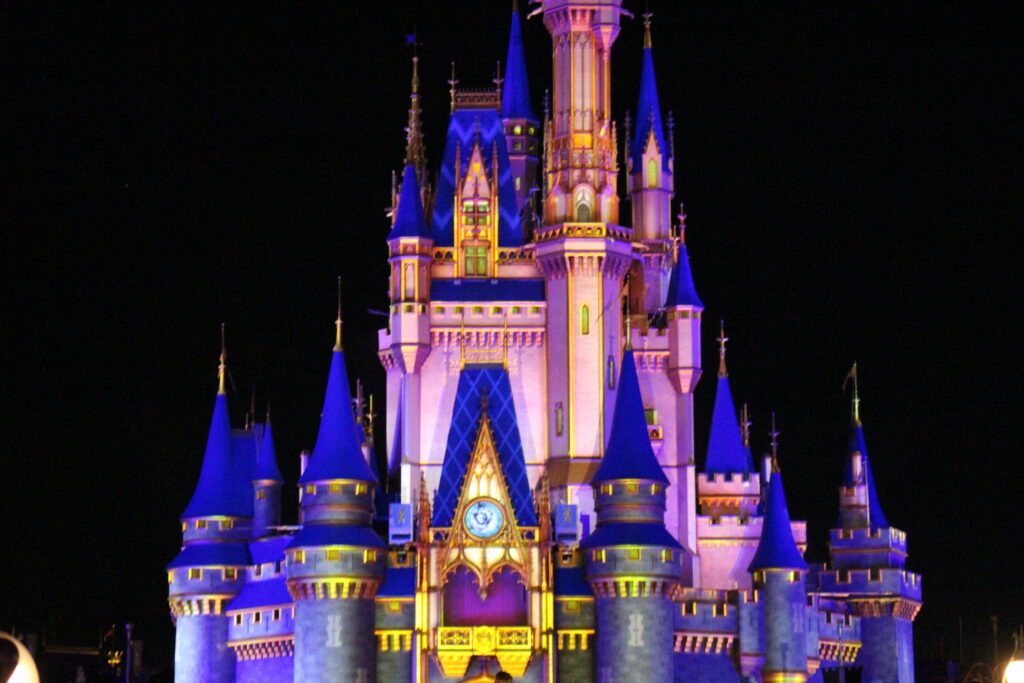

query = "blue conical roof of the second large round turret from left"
[[299, 349, 377, 483]]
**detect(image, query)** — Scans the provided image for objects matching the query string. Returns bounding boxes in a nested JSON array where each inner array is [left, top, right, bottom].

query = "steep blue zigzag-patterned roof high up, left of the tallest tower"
[[430, 110, 523, 247]]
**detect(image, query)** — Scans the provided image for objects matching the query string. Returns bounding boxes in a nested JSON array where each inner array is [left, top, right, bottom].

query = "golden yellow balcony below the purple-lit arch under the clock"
[[436, 626, 534, 679]]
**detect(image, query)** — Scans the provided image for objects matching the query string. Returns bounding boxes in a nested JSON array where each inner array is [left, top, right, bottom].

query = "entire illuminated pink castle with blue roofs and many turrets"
[[168, 0, 922, 683]]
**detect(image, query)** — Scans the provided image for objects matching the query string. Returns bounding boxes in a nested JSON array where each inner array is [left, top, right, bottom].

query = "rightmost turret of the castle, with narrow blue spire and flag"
[[818, 364, 922, 683]]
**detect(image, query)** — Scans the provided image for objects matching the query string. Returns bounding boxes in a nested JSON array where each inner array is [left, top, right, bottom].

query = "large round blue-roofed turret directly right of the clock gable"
[[581, 348, 683, 683]]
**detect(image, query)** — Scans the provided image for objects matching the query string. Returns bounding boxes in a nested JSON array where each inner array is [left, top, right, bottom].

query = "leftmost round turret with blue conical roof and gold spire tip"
[[167, 327, 253, 683]]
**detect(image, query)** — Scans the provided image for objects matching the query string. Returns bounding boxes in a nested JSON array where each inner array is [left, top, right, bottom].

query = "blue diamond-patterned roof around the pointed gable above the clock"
[[433, 365, 537, 526]]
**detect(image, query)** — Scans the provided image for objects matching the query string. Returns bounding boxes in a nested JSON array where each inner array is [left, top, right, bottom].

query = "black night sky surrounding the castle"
[[0, 0, 1024, 663]]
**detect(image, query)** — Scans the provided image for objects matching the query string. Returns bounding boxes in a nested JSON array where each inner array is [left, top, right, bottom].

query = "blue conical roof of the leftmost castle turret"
[[181, 393, 253, 519]]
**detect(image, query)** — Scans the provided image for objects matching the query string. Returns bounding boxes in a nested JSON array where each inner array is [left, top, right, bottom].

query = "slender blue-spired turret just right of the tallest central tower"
[[626, 12, 675, 313]]
